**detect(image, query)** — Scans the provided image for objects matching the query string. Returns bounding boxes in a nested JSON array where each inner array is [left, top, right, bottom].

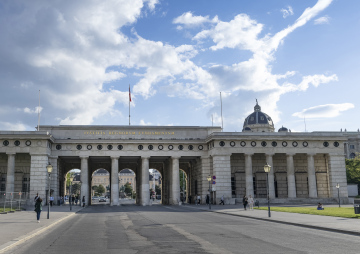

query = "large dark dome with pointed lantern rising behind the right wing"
[[243, 100, 275, 132]]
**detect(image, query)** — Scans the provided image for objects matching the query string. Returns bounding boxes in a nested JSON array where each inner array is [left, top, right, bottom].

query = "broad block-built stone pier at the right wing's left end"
[[212, 155, 235, 204]]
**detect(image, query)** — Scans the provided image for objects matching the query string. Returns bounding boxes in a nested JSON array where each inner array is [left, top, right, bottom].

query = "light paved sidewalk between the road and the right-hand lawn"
[[184, 204, 360, 236]]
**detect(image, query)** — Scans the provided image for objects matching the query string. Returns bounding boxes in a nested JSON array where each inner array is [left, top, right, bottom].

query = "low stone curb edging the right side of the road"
[[186, 208, 360, 236]]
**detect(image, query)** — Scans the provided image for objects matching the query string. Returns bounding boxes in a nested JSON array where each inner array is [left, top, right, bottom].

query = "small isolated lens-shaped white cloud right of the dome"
[[293, 103, 355, 118]]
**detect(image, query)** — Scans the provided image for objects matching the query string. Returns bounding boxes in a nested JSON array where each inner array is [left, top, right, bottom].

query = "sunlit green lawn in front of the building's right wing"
[[255, 206, 360, 218]]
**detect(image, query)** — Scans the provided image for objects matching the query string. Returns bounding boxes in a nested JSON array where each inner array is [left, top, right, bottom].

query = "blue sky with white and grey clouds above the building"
[[0, 0, 360, 131]]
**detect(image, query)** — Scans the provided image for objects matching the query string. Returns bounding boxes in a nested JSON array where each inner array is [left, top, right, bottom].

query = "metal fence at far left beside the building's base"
[[0, 191, 29, 212]]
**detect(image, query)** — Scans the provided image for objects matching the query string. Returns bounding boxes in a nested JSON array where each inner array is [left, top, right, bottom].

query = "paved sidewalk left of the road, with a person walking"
[[0, 205, 82, 253]]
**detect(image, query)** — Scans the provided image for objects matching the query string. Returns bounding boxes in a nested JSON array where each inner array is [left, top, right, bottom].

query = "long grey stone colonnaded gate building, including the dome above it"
[[0, 104, 349, 205]]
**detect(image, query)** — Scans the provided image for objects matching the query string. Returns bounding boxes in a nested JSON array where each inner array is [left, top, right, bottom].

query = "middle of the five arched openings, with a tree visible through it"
[[119, 168, 137, 204]]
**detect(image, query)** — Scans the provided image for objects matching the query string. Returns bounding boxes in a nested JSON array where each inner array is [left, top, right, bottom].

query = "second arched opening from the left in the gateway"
[[90, 168, 110, 205]]
